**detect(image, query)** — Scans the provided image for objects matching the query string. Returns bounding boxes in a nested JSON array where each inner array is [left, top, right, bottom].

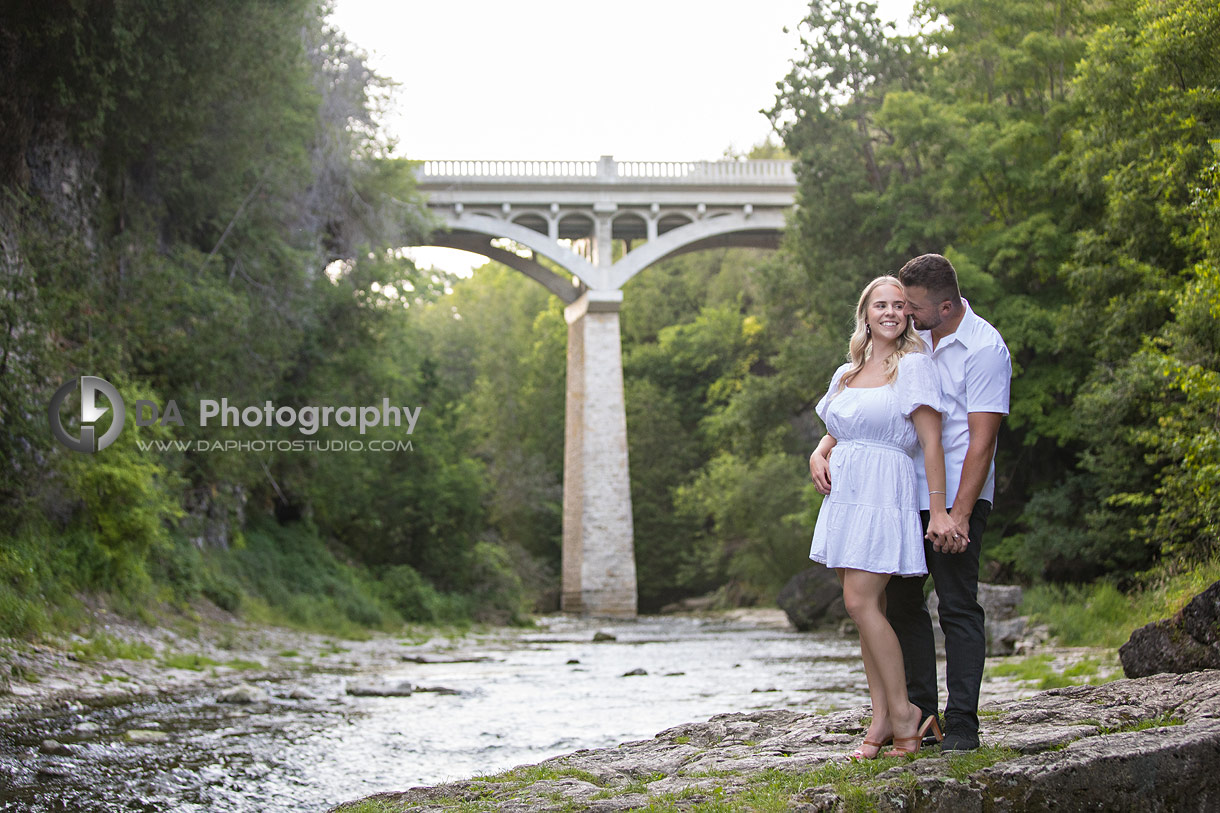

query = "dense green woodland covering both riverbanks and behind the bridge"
[[0, 0, 1220, 641]]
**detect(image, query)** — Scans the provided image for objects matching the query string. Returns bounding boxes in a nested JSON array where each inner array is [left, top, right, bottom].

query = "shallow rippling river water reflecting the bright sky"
[[0, 616, 867, 813]]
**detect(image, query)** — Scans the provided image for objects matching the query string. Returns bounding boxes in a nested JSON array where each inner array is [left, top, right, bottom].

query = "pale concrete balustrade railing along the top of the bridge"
[[416, 157, 795, 186]]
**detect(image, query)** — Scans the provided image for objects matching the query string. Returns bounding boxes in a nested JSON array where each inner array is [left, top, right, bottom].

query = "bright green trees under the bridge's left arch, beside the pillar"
[[417, 264, 567, 607]]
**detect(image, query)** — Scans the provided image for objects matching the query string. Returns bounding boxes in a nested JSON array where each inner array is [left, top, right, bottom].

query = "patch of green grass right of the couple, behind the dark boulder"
[[1021, 557, 1220, 648]]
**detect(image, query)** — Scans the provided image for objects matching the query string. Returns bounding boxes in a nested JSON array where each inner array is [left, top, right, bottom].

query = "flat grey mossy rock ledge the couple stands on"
[[332, 670, 1220, 813]]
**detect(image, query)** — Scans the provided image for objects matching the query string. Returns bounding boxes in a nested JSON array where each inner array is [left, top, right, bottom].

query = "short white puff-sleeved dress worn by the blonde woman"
[[809, 353, 943, 576]]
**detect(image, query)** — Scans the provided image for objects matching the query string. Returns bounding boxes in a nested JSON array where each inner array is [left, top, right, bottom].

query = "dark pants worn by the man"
[[886, 499, 992, 734]]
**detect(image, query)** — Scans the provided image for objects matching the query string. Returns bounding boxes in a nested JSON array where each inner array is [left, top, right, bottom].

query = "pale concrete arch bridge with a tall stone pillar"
[[416, 156, 797, 616]]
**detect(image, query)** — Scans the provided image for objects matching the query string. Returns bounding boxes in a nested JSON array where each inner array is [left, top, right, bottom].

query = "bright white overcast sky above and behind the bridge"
[[331, 0, 913, 273]]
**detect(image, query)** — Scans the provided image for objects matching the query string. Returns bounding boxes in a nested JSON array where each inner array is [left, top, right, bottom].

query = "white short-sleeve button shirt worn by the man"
[[915, 299, 1013, 510]]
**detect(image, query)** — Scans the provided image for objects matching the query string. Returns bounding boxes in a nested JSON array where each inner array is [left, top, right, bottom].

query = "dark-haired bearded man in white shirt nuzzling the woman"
[[809, 254, 1013, 751]]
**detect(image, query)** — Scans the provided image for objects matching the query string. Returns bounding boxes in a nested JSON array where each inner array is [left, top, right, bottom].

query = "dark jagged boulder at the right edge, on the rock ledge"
[[1119, 581, 1220, 678]]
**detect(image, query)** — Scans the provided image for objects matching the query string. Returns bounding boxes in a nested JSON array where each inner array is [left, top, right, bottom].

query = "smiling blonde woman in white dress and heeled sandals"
[[809, 276, 953, 759]]
